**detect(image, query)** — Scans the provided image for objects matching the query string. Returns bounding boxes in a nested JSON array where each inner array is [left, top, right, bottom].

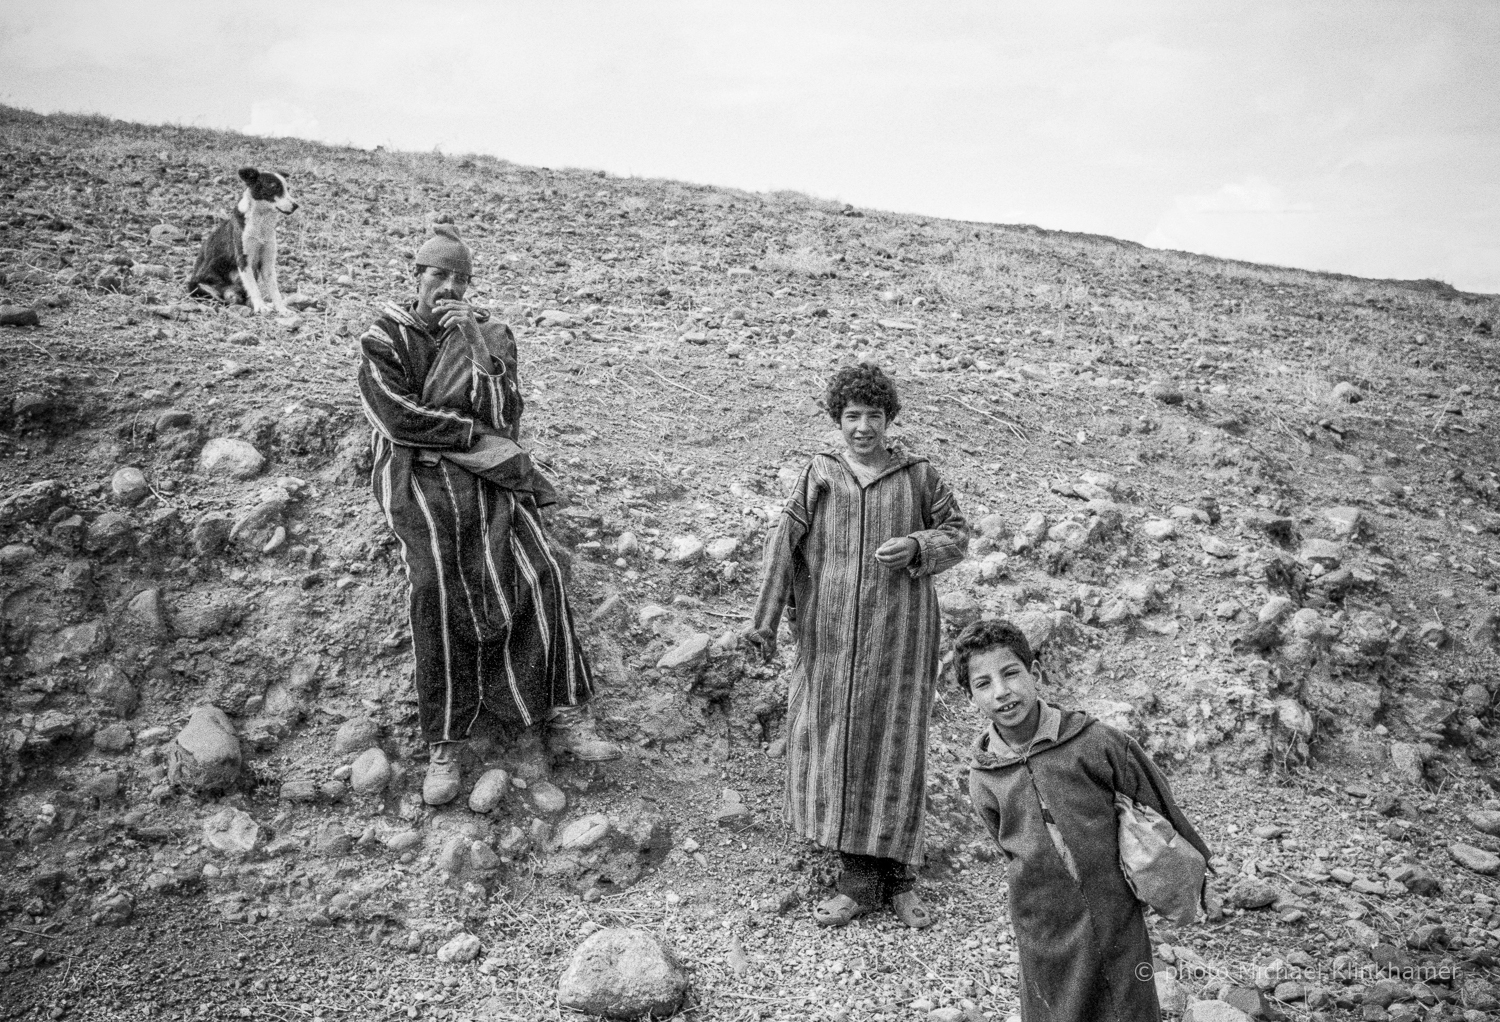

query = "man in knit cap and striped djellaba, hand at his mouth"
[[359, 224, 620, 806]]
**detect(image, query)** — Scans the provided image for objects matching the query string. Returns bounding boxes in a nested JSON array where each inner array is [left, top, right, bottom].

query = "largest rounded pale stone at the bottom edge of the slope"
[[558, 927, 687, 1019]]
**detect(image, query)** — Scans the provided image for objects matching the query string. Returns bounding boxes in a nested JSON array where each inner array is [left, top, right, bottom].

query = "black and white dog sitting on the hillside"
[[188, 167, 297, 314]]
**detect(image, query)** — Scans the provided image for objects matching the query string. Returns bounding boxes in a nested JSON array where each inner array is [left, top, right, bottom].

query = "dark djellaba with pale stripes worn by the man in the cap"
[[359, 305, 593, 741]]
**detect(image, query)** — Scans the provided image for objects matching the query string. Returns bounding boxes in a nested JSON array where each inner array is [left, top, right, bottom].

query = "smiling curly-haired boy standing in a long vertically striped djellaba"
[[744, 365, 969, 927]]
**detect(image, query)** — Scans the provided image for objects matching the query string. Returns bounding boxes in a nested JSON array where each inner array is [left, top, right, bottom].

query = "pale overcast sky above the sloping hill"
[[0, 0, 1500, 293]]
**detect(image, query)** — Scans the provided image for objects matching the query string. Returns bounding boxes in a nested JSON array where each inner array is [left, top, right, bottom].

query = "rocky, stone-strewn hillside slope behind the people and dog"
[[0, 108, 1500, 1020]]
